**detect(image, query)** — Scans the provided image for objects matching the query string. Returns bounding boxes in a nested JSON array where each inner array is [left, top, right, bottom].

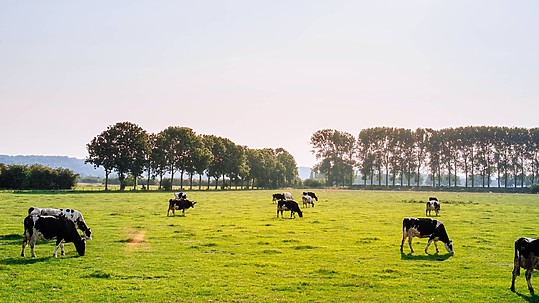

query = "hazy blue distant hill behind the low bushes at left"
[[0, 155, 105, 178]]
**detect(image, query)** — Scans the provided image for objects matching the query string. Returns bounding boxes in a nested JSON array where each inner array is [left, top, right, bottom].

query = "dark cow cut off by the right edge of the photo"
[[511, 238, 539, 296]]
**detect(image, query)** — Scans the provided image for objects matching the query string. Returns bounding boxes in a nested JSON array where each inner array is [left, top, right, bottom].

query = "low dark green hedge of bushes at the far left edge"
[[0, 163, 78, 190]]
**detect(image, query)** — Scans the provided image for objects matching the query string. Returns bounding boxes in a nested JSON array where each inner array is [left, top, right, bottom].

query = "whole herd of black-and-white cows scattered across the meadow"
[[17, 192, 539, 295]]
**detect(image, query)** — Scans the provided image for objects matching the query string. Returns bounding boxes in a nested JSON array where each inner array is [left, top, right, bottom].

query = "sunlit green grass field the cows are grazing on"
[[0, 190, 539, 302]]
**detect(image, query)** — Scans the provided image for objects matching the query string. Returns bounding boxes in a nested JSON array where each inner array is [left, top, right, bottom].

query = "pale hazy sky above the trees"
[[0, 0, 539, 167]]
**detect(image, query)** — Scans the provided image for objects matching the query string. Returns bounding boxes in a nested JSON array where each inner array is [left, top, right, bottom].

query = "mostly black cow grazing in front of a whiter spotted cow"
[[21, 216, 86, 258]]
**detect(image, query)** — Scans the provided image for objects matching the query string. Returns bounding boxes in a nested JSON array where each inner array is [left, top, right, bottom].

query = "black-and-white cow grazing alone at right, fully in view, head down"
[[401, 217, 454, 254]]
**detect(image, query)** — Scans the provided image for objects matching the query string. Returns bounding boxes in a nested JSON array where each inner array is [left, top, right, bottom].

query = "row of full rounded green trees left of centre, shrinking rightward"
[[85, 122, 298, 190]]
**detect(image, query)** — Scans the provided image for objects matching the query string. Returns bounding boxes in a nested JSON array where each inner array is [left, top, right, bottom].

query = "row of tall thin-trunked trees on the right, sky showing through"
[[311, 126, 539, 187]]
